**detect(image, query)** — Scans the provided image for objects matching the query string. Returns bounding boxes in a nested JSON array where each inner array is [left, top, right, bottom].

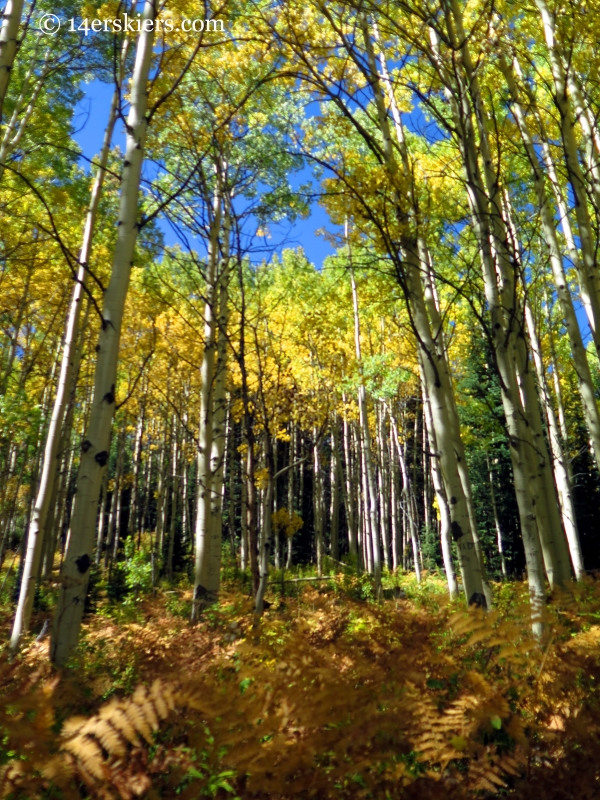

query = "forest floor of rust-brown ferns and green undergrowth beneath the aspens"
[[0, 564, 600, 800]]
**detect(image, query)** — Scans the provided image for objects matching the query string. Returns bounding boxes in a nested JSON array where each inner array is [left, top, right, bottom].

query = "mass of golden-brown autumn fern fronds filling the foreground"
[[5, 585, 600, 800]]
